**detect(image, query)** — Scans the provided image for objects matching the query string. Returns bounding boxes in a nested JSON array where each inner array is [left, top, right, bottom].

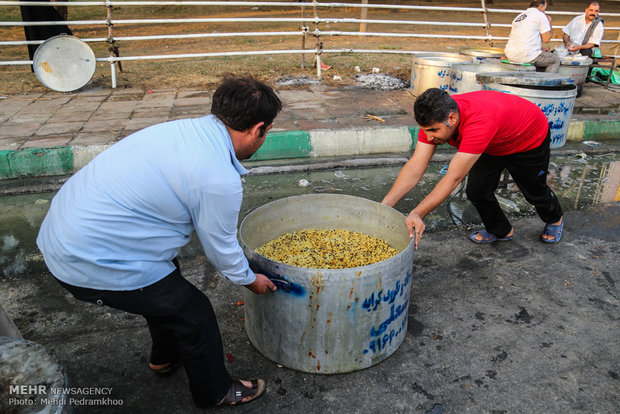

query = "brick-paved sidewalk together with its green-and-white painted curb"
[[0, 83, 620, 178]]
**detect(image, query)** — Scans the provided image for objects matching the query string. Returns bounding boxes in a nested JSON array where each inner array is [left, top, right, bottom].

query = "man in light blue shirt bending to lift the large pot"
[[37, 77, 282, 407]]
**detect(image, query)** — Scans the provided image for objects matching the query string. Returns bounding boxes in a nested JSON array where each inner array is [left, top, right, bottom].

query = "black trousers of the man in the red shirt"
[[466, 132, 563, 237]]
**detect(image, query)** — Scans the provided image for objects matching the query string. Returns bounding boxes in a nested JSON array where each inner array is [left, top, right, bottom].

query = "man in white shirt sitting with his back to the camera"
[[504, 0, 560, 72]]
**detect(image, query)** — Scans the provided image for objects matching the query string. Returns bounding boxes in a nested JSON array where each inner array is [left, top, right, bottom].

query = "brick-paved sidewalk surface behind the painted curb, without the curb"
[[0, 79, 620, 155]]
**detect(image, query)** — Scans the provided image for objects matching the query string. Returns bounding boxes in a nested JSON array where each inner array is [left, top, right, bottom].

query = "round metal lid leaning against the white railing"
[[33, 35, 96, 92]]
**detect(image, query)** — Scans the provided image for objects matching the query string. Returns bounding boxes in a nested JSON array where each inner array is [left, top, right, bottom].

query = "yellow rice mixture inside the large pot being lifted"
[[256, 229, 398, 269]]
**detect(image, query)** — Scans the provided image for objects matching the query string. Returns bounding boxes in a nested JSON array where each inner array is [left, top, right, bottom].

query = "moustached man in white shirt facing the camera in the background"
[[562, 1, 604, 57]]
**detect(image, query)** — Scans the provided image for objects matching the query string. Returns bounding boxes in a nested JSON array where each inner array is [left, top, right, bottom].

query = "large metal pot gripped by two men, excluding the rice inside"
[[239, 194, 414, 374]]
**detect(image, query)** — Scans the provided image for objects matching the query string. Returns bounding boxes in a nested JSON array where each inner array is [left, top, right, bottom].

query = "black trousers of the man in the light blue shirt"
[[58, 259, 232, 407]]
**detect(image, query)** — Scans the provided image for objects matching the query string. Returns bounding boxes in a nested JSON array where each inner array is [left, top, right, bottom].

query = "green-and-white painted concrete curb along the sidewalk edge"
[[0, 120, 620, 179]]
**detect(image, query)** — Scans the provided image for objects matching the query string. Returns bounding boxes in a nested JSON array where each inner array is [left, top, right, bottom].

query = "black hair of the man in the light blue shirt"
[[211, 75, 282, 135]]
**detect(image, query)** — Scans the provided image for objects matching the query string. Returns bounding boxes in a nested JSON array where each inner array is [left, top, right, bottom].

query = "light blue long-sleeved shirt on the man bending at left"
[[37, 115, 256, 290]]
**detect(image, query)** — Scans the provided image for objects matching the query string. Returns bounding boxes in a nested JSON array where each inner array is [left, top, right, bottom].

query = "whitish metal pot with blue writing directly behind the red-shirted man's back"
[[476, 72, 577, 148]]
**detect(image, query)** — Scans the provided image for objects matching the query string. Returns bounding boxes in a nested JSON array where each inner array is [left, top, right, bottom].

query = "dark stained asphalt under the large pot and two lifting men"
[[0, 202, 620, 414]]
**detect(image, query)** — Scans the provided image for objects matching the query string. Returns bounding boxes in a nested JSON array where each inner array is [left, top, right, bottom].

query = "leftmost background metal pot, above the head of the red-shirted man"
[[411, 53, 475, 96]]
